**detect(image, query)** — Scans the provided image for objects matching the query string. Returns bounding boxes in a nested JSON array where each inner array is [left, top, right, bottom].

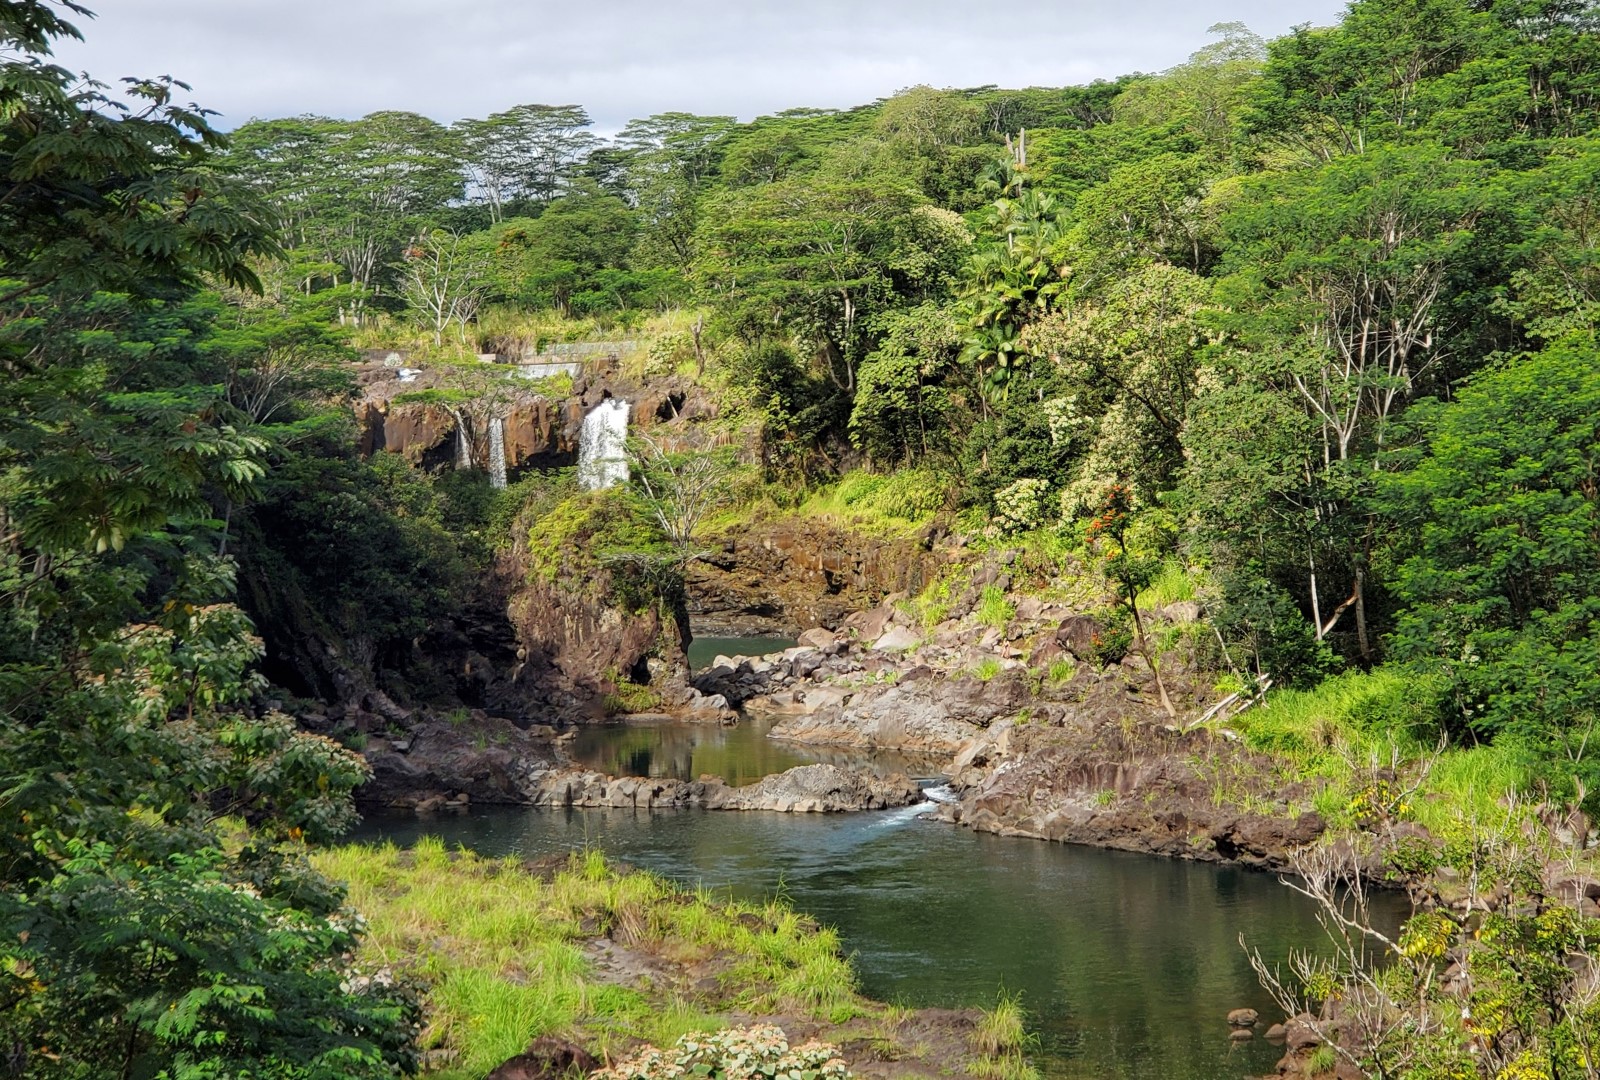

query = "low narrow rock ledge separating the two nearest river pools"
[[531, 765, 922, 813]]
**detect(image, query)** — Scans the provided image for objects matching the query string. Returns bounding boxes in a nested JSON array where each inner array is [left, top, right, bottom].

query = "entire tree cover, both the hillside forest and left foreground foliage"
[[0, 0, 1600, 1077]]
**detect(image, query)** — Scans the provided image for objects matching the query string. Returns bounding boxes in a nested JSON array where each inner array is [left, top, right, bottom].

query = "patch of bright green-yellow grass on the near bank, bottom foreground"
[[314, 837, 872, 1080]]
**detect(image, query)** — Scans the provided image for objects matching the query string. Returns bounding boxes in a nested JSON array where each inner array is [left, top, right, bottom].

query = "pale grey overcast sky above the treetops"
[[58, 0, 1344, 131]]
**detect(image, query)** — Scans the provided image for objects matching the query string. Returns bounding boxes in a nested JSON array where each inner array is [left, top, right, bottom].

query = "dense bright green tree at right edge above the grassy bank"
[[1384, 331, 1600, 764]]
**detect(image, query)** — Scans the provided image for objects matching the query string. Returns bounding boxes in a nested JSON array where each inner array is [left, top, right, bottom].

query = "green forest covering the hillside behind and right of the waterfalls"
[[216, 0, 1600, 806]]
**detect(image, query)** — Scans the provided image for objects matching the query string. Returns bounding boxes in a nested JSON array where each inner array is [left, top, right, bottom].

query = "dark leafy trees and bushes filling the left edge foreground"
[[0, 0, 416, 1080]]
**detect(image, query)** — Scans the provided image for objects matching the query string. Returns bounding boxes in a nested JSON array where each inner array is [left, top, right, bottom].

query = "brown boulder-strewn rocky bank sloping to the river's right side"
[[694, 582, 1325, 869]]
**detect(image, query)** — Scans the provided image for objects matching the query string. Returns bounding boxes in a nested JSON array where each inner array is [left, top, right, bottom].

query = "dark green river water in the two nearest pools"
[[362, 710, 1400, 1080]]
